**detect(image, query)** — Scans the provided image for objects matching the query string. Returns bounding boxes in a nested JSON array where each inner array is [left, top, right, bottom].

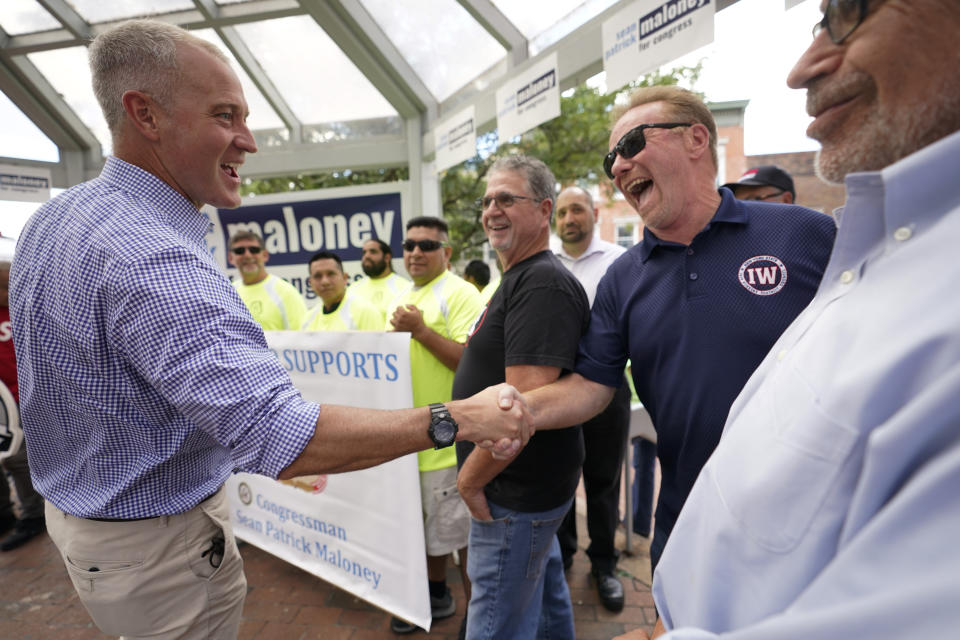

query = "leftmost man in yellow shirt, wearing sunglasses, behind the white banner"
[[227, 231, 307, 331]]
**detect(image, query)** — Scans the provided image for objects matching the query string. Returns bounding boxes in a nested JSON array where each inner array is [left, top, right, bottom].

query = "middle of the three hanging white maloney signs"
[[497, 52, 560, 142]]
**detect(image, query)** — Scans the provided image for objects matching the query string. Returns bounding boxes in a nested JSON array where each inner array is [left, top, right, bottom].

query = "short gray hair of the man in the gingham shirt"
[[89, 20, 230, 138]]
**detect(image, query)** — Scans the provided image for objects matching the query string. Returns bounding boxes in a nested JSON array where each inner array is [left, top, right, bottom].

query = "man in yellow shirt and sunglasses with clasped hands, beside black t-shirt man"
[[386, 216, 483, 633]]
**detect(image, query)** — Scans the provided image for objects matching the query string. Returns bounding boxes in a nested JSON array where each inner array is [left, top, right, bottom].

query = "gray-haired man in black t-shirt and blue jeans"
[[453, 155, 590, 640]]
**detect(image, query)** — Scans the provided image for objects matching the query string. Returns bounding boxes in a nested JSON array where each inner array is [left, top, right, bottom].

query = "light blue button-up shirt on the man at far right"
[[653, 133, 960, 640]]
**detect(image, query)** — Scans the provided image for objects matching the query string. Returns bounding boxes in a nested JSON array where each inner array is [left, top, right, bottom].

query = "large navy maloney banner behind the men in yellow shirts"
[[203, 182, 410, 305]]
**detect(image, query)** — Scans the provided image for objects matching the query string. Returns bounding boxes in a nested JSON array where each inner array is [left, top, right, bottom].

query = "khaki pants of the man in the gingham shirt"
[[46, 488, 247, 639]]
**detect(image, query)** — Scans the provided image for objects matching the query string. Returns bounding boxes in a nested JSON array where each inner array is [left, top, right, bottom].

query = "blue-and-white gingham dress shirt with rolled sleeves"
[[10, 158, 320, 518]]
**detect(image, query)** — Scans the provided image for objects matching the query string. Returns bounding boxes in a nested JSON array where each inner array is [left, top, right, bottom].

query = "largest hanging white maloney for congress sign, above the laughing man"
[[602, 0, 715, 91]]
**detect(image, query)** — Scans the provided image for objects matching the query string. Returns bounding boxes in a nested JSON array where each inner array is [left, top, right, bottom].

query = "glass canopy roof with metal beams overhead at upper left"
[[0, 0, 632, 168]]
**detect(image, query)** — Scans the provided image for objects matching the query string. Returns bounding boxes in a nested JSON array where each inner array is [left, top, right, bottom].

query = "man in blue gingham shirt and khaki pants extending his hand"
[[10, 21, 529, 638]]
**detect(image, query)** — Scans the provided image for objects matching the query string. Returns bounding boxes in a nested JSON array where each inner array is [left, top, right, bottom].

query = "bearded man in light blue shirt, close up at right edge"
[[608, 0, 960, 640]]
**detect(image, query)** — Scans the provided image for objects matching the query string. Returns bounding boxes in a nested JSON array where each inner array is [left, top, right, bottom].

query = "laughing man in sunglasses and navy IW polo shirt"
[[556, 86, 835, 580]]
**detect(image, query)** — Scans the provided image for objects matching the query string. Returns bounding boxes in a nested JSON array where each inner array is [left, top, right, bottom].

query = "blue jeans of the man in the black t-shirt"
[[467, 497, 574, 640]]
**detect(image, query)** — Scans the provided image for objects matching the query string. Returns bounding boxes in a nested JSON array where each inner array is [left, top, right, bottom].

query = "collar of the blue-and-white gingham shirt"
[[100, 156, 210, 243]]
